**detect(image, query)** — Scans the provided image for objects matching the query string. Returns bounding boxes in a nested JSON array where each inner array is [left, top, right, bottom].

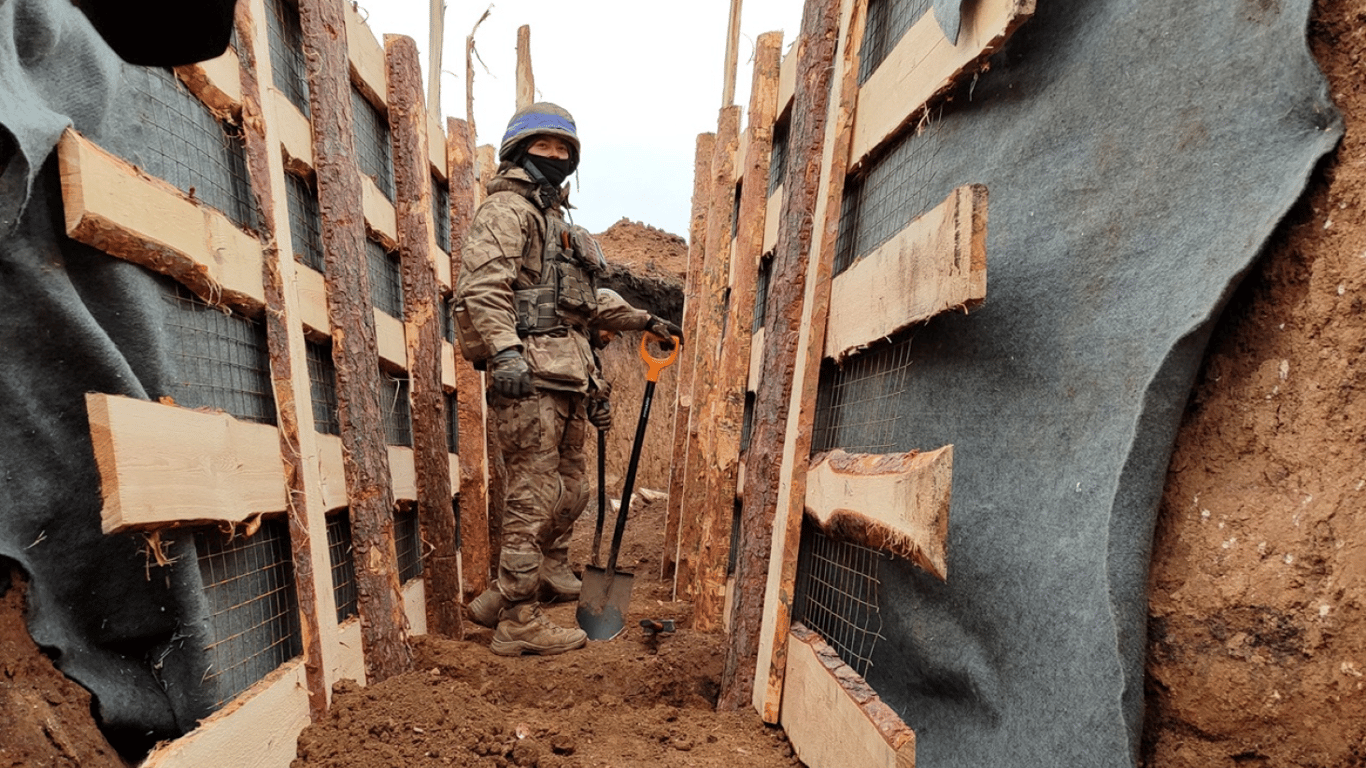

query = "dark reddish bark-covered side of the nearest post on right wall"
[[727, 0, 861, 723]]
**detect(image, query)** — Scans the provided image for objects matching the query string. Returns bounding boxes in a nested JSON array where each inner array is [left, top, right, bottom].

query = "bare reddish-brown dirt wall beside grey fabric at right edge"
[[1143, 0, 1366, 768]]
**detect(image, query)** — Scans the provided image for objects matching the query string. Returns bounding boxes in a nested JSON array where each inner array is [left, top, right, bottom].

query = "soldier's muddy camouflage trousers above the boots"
[[489, 389, 589, 603]]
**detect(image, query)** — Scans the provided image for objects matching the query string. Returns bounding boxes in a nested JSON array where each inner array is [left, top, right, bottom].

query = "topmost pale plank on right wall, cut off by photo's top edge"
[[850, 0, 1034, 167]]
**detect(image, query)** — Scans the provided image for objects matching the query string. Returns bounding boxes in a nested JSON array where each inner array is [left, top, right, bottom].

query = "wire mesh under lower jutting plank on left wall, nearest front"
[[194, 519, 302, 708]]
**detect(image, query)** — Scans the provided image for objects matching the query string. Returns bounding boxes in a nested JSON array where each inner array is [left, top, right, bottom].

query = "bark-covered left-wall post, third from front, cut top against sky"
[[384, 34, 463, 638]]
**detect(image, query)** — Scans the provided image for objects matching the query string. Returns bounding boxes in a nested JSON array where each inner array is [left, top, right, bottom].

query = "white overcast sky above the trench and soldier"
[[357, 0, 802, 238]]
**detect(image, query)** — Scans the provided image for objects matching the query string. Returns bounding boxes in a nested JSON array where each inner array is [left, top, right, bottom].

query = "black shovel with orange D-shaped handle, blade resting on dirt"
[[575, 332, 680, 640]]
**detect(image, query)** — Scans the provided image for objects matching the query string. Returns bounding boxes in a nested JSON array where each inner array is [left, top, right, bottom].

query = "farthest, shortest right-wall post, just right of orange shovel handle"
[[660, 134, 716, 578]]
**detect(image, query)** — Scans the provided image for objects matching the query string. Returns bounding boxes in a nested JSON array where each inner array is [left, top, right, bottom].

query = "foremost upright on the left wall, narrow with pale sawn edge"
[[234, 3, 337, 716]]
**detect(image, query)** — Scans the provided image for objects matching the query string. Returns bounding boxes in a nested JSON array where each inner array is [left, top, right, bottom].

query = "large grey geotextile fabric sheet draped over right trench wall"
[[836, 0, 1341, 768]]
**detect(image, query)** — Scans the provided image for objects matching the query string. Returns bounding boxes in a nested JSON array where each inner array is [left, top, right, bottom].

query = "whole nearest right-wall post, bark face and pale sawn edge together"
[[748, 0, 866, 723]]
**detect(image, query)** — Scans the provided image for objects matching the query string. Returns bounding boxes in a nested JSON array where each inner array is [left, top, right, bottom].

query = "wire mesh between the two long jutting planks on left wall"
[[161, 280, 276, 424]]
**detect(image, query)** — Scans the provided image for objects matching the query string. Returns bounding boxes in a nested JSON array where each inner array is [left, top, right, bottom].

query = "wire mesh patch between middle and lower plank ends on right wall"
[[811, 332, 911, 454]]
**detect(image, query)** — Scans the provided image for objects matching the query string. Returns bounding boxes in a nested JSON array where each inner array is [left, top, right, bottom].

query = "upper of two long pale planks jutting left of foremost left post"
[[57, 128, 265, 312]]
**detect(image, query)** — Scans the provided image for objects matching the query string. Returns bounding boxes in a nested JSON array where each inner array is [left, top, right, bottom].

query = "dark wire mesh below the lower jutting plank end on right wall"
[[792, 519, 887, 678]]
